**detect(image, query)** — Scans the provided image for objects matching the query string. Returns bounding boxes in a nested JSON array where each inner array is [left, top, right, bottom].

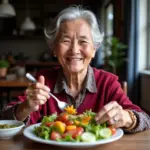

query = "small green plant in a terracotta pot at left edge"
[[0, 60, 9, 77]]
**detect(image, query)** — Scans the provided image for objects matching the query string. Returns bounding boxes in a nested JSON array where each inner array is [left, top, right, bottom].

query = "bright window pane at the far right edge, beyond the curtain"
[[137, 0, 150, 72]]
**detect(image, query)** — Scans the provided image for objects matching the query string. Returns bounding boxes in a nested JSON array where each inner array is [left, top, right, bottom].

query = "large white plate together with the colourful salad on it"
[[24, 106, 123, 148]]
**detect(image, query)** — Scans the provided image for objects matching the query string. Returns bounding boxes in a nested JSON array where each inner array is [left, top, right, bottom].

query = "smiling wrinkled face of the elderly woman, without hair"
[[54, 19, 95, 73]]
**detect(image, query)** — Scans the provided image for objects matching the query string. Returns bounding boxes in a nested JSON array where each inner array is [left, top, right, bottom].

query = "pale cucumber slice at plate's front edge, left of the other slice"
[[81, 132, 96, 142]]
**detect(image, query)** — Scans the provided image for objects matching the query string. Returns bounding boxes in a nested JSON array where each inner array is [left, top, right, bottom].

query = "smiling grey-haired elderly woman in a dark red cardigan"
[[2, 7, 150, 133]]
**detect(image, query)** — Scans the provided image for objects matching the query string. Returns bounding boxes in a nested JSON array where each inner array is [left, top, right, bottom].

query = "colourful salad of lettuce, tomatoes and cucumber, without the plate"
[[33, 106, 116, 142]]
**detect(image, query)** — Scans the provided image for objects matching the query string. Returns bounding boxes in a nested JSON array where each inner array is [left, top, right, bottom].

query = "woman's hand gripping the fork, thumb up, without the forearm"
[[25, 76, 50, 112]]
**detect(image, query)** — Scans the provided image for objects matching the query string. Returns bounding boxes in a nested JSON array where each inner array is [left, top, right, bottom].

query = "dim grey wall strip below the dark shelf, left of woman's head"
[[0, 40, 48, 60]]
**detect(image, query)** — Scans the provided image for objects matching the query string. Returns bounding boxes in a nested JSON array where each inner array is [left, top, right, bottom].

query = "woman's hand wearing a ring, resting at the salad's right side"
[[95, 101, 133, 128]]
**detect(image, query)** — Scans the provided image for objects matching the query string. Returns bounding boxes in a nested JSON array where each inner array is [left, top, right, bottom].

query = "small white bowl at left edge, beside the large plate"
[[0, 120, 24, 139]]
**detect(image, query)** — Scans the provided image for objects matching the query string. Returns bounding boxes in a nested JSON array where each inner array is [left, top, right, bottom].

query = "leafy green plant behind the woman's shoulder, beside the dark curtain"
[[104, 37, 127, 74]]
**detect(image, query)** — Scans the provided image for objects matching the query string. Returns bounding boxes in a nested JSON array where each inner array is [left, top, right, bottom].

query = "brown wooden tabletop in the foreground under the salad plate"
[[0, 130, 150, 150]]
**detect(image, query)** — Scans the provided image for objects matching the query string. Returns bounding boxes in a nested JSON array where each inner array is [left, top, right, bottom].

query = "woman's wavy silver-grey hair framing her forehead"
[[44, 6, 103, 49]]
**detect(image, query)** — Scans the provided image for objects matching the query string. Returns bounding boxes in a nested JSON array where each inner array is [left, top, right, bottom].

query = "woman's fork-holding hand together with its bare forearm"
[[15, 76, 50, 121]]
